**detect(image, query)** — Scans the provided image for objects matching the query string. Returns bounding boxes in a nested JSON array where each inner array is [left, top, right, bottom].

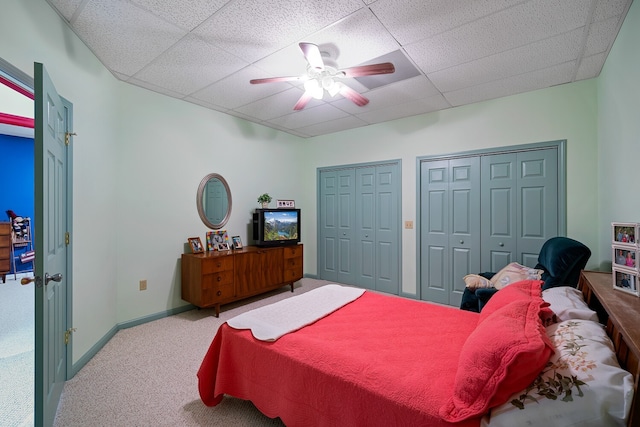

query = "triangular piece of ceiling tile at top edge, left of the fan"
[[130, 0, 228, 30]]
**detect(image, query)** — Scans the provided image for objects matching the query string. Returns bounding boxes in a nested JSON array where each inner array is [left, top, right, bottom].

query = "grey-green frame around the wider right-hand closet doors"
[[415, 139, 567, 299]]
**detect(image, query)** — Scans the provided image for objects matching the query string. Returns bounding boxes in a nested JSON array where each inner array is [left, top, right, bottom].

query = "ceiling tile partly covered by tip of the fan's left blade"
[[192, 66, 291, 109]]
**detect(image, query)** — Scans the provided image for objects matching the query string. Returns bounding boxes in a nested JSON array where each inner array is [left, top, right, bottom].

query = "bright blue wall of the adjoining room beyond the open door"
[[0, 134, 34, 272]]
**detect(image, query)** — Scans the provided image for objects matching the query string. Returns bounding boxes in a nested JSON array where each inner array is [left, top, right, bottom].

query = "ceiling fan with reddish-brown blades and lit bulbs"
[[249, 42, 395, 110]]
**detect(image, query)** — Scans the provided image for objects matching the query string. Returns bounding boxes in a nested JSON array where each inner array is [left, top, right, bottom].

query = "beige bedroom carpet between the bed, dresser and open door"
[[54, 279, 329, 427]]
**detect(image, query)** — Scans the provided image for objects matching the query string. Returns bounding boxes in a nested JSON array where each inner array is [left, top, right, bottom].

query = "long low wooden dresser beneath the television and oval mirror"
[[182, 244, 303, 316]]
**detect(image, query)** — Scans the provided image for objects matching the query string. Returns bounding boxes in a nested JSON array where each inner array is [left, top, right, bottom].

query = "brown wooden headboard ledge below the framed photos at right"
[[578, 271, 640, 427]]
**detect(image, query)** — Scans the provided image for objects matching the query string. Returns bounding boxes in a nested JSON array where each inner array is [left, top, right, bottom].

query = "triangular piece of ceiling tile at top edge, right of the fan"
[[371, 0, 521, 45]]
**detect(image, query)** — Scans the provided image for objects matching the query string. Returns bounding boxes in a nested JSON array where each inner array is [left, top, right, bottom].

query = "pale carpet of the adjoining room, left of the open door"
[[0, 274, 35, 427]]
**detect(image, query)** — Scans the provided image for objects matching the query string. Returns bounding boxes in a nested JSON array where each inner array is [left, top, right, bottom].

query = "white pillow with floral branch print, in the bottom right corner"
[[481, 319, 633, 427]]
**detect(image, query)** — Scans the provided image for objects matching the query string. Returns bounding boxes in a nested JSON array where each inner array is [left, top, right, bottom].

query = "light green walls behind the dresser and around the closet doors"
[[0, 0, 640, 368]]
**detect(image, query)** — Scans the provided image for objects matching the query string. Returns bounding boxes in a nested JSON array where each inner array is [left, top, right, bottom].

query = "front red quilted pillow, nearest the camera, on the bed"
[[439, 298, 553, 422]]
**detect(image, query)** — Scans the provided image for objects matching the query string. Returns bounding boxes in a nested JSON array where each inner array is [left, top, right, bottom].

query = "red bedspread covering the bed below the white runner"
[[198, 292, 480, 427]]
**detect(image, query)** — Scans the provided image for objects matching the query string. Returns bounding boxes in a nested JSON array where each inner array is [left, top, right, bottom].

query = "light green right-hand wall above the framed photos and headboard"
[[594, 1, 640, 268]]
